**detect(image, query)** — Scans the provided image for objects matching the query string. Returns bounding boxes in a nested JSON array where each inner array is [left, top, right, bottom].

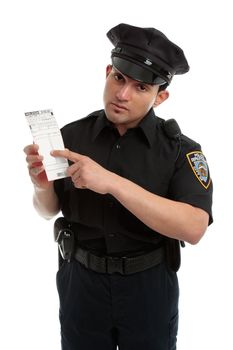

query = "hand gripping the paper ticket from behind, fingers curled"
[[24, 144, 52, 189]]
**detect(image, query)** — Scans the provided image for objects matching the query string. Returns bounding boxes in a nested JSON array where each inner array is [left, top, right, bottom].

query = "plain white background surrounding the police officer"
[[0, 0, 233, 350]]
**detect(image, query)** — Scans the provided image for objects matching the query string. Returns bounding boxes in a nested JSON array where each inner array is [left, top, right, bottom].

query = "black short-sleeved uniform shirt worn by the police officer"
[[54, 109, 212, 254]]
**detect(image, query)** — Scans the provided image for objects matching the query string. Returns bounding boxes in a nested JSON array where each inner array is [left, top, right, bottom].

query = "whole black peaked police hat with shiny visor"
[[107, 23, 189, 85]]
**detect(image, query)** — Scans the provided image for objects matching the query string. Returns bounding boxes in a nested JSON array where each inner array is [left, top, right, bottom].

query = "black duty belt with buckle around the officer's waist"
[[73, 247, 164, 275]]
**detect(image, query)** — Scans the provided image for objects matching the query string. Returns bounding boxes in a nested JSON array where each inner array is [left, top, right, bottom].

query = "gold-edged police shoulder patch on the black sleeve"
[[186, 151, 211, 189]]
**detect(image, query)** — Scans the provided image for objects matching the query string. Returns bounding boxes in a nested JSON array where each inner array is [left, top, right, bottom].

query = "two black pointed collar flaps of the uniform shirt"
[[92, 108, 158, 147]]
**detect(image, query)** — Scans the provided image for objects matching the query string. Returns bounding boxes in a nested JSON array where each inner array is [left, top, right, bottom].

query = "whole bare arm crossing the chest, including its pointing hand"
[[49, 149, 209, 244]]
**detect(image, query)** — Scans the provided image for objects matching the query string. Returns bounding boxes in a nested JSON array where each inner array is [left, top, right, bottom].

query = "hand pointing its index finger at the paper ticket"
[[51, 149, 115, 194]]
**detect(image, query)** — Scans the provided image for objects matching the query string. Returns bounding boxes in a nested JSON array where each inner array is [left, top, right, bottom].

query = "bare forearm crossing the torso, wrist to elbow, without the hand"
[[109, 174, 208, 244]]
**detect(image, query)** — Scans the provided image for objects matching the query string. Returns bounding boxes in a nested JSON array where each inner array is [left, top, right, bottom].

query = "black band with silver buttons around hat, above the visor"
[[111, 46, 173, 84]]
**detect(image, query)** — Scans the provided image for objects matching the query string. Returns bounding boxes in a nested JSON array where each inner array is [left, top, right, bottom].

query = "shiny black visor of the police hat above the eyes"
[[112, 56, 167, 85]]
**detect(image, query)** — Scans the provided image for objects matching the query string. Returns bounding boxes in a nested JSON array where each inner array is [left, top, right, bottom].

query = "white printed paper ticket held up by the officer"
[[25, 109, 69, 181]]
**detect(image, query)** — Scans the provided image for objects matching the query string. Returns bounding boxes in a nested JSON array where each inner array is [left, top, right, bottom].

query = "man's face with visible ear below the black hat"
[[104, 65, 168, 134]]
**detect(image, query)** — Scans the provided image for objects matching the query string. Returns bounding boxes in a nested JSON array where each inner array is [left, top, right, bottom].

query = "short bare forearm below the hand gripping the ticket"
[[33, 185, 60, 219]]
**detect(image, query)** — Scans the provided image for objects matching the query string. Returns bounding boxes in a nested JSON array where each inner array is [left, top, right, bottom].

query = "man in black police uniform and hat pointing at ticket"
[[25, 24, 212, 350]]
